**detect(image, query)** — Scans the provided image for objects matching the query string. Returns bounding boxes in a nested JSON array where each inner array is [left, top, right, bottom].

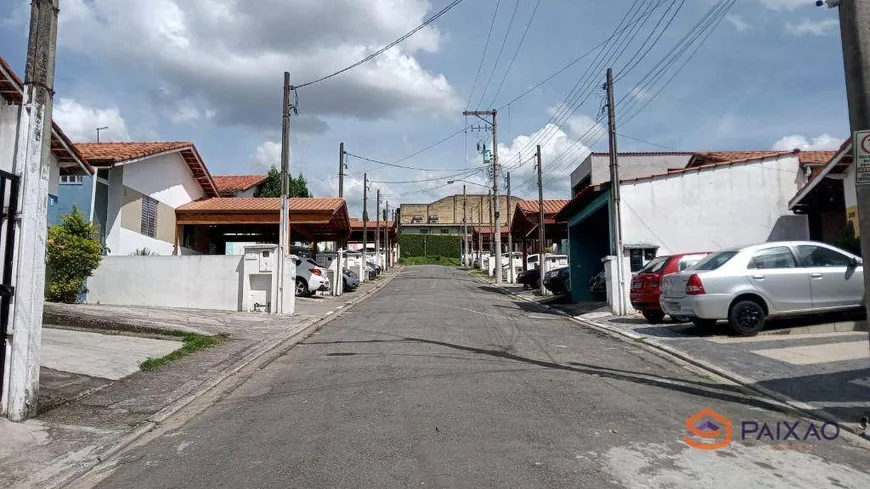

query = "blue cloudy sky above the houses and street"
[[0, 0, 849, 216]]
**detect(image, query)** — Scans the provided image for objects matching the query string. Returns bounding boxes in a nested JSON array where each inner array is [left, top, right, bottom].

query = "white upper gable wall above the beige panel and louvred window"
[[122, 153, 205, 208]]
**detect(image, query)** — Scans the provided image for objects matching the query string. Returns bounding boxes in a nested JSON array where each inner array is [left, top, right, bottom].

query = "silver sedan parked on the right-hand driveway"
[[659, 241, 864, 336]]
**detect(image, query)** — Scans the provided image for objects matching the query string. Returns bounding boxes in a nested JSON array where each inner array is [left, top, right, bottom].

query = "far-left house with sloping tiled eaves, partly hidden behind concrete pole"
[[0, 58, 93, 214]]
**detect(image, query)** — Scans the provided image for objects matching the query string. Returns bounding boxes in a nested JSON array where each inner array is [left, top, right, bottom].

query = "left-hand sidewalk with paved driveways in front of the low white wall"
[[0, 268, 400, 488]]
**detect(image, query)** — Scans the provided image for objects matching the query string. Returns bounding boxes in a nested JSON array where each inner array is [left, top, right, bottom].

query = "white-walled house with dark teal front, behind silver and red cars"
[[555, 150, 825, 308]]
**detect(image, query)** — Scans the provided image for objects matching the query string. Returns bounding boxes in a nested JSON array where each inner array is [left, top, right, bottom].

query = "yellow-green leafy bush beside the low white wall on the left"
[[45, 207, 103, 304]]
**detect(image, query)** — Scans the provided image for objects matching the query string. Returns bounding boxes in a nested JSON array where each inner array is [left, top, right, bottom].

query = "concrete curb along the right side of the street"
[[469, 268, 870, 448]]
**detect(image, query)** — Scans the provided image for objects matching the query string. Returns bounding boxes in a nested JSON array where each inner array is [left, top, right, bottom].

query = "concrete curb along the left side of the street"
[[33, 266, 404, 489]]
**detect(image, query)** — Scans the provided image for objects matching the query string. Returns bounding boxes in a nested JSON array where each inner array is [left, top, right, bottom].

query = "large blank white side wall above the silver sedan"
[[621, 155, 799, 255]]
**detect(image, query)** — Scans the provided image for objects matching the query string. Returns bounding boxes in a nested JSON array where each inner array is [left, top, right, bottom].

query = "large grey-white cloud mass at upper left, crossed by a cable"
[[52, 0, 460, 131]]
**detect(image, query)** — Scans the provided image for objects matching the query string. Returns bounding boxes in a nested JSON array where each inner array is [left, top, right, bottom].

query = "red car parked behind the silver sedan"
[[629, 252, 710, 324]]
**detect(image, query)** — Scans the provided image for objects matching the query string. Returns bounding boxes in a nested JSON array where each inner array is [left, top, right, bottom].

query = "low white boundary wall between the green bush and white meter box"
[[87, 255, 242, 311]]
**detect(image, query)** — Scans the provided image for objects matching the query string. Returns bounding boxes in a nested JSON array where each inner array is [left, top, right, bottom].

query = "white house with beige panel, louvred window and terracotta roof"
[[76, 142, 219, 255]]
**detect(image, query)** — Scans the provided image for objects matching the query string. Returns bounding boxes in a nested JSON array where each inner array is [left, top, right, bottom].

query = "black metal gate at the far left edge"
[[0, 170, 19, 402]]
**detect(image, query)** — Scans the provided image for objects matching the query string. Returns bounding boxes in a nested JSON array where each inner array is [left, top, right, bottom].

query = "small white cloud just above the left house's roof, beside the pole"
[[52, 98, 130, 142]]
